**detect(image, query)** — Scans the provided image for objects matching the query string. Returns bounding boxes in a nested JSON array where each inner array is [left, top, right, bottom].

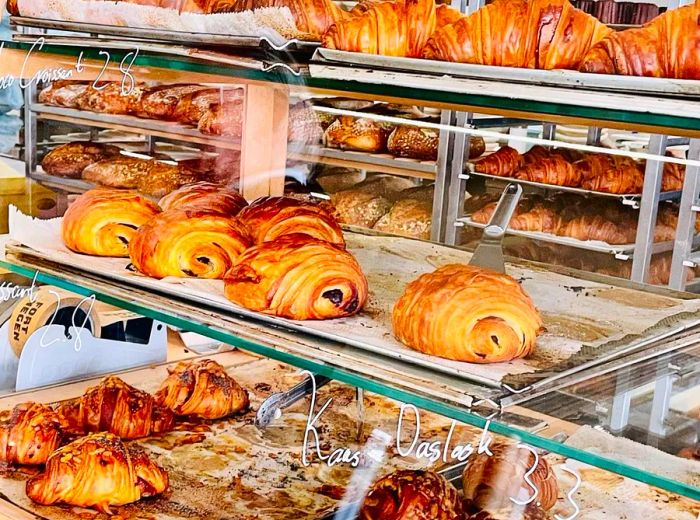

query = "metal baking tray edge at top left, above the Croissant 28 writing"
[[10, 16, 320, 54]]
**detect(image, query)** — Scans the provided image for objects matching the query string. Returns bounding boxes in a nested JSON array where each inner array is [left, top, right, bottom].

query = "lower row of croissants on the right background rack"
[[471, 194, 700, 245]]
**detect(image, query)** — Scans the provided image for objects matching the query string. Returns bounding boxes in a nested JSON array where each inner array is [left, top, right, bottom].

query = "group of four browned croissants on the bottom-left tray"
[[0, 359, 249, 514]]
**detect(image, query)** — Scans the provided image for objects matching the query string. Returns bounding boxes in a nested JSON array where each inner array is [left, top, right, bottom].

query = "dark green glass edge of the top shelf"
[[5, 42, 700, 134]]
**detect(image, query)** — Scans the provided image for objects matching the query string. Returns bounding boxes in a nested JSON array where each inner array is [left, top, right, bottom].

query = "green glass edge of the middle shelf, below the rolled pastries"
[[0, 260, 700, 500]]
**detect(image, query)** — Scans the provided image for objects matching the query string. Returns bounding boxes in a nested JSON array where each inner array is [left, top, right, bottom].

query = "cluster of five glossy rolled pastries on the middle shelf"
[[62, 183, 367, 320]]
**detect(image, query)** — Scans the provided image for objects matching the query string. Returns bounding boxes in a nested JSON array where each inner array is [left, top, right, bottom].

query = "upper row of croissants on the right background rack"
[[473, 146, 685, 195]]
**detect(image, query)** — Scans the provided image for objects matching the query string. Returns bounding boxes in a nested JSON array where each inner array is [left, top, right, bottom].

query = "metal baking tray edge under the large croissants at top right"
[[313, 47, 700, 99]]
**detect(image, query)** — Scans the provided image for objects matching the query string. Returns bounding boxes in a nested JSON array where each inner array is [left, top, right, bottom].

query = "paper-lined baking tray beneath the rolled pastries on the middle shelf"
[[10, 208, 700, 392]]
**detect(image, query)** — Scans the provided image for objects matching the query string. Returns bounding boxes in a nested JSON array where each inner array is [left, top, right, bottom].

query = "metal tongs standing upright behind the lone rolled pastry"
[[469, 183, 523, 273]]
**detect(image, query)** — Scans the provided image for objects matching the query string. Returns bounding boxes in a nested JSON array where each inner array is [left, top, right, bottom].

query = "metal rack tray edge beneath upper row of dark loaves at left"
[[29, 103, 241, 150]]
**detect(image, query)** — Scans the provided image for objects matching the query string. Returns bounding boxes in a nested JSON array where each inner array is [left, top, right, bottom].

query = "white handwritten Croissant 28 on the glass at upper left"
[[0, 37, 140, 96]]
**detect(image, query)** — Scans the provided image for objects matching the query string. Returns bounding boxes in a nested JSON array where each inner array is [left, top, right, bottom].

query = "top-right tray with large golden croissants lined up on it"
[[311, 0, 700, 93]]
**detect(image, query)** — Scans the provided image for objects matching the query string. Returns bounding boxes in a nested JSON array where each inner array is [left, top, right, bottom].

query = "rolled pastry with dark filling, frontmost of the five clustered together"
[[224, 234, 367, 320]]
